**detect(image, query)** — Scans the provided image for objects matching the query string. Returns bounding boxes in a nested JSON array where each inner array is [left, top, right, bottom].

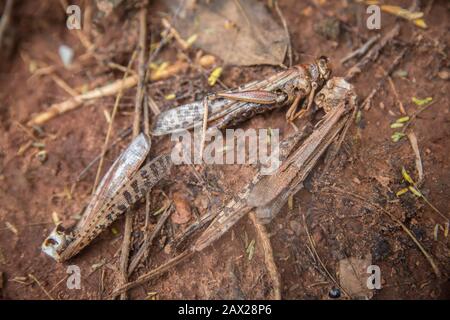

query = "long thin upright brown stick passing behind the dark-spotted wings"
[[119, 1, 148, 300]]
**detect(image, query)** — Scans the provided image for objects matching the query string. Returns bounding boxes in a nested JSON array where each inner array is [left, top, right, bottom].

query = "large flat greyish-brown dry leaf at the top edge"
[[167, 0, 288, 65]]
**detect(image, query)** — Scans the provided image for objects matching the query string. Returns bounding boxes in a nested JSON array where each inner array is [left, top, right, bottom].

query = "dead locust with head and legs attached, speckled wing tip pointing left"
[[152, 57, 331, 136]]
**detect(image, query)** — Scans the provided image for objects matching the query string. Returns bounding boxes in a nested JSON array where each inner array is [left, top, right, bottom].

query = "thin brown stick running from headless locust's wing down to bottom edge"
[[250, 212, 281, 300]]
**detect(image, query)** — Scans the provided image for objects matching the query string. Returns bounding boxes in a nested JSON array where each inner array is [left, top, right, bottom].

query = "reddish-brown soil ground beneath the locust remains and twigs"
[[0, 0, 450, 299]]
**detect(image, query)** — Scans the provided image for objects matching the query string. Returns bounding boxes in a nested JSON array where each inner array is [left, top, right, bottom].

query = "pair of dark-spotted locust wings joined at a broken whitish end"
[[42, 134, 171, 262]]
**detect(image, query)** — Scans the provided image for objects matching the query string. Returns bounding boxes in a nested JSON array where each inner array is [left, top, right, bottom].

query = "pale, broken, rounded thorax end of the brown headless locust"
[[314, 77, 356, 113]]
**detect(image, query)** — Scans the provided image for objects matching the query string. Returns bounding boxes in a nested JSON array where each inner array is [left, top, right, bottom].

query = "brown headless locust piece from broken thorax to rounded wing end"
[[247, 77, 356, 223]]
